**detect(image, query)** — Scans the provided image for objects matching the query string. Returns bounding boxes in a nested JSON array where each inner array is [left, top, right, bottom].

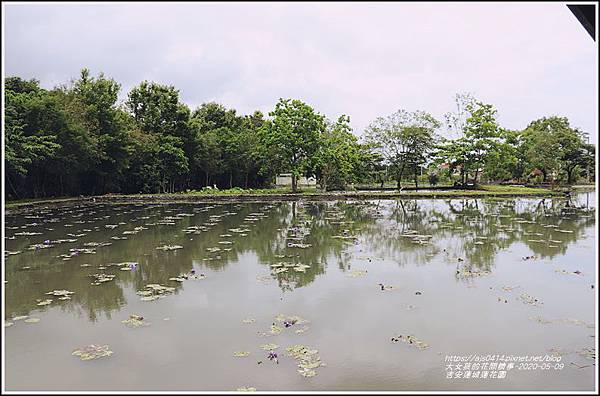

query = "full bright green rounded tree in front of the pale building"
[[261, 99, 325, 193]]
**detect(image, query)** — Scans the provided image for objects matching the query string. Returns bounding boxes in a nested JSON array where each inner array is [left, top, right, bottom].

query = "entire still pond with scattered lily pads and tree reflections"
[[4, 192, 596, 391]]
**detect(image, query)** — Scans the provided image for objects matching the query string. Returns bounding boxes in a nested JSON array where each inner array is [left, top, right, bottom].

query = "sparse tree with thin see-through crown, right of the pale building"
[[366, 110, 440, 189]]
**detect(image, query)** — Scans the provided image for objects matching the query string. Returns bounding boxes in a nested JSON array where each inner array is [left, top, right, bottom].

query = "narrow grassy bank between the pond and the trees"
[[4, 185, 584, 213]]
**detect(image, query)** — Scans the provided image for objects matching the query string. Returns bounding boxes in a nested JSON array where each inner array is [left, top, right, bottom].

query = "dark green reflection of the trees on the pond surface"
[[5, 193, 595, 321]]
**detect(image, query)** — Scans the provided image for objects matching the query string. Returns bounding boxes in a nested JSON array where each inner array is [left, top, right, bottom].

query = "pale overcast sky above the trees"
[[3, 3, 598, 142]]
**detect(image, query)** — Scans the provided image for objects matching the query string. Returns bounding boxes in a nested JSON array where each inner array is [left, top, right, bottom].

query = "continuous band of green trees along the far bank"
[[4, 69, 594, 199]]
